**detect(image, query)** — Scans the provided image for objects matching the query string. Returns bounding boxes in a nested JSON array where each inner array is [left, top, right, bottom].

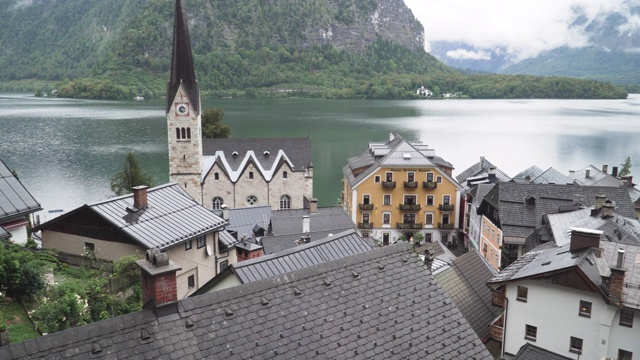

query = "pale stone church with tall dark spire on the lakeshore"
[[166, 1, 313, 210]]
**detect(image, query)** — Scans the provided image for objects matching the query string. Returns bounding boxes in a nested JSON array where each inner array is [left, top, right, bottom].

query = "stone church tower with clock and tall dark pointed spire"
[[166, 0, 202, 203]]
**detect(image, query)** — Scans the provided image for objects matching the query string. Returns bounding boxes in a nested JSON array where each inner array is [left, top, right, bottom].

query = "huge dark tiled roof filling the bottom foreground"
[[0, 245, 492, 360]]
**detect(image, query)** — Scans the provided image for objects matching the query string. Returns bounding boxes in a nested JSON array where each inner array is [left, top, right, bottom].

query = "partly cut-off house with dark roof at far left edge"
[[0, 159, 42, 244]]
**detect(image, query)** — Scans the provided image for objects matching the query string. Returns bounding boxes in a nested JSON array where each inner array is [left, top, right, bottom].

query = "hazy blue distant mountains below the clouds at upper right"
[[424, 6, 640, 86]]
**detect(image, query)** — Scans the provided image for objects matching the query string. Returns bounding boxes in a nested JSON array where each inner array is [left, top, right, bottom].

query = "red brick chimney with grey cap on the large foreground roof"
[[136, 249, 182, 309]]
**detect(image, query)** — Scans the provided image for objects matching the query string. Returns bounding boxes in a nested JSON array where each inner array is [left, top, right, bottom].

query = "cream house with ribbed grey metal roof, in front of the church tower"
[[33, 184, 231, 299]]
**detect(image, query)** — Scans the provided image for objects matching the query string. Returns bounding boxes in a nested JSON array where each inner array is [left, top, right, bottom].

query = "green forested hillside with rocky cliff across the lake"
[[0, 0, 626, 98]]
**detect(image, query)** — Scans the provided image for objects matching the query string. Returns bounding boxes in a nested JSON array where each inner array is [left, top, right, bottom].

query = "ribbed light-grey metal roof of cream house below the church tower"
[[34, 184, 226, 250]]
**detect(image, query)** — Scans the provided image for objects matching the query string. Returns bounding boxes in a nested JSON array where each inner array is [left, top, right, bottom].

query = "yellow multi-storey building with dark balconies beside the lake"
[[342, 134, 462, 245]]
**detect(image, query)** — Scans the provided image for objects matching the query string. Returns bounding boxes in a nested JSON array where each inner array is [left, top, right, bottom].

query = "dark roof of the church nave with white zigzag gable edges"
[[202, 137, 313, 171]]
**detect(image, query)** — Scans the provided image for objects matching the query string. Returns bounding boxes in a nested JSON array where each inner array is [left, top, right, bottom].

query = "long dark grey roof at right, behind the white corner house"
[[480, 182, 637, 239]]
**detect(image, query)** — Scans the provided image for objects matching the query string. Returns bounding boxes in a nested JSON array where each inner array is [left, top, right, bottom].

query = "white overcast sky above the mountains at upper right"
[[405, 0, 640, 59]]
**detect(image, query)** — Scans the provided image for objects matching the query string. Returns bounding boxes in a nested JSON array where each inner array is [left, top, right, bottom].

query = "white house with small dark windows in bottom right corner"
[[488, 228, 640, 360]]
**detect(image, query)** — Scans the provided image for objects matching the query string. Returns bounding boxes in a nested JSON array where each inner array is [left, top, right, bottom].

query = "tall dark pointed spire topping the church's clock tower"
[[166, 0, 200, 113]]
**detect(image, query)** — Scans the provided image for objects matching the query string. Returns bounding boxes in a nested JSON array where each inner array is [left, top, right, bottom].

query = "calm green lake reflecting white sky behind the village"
[[0, 93, 640, 218]]
